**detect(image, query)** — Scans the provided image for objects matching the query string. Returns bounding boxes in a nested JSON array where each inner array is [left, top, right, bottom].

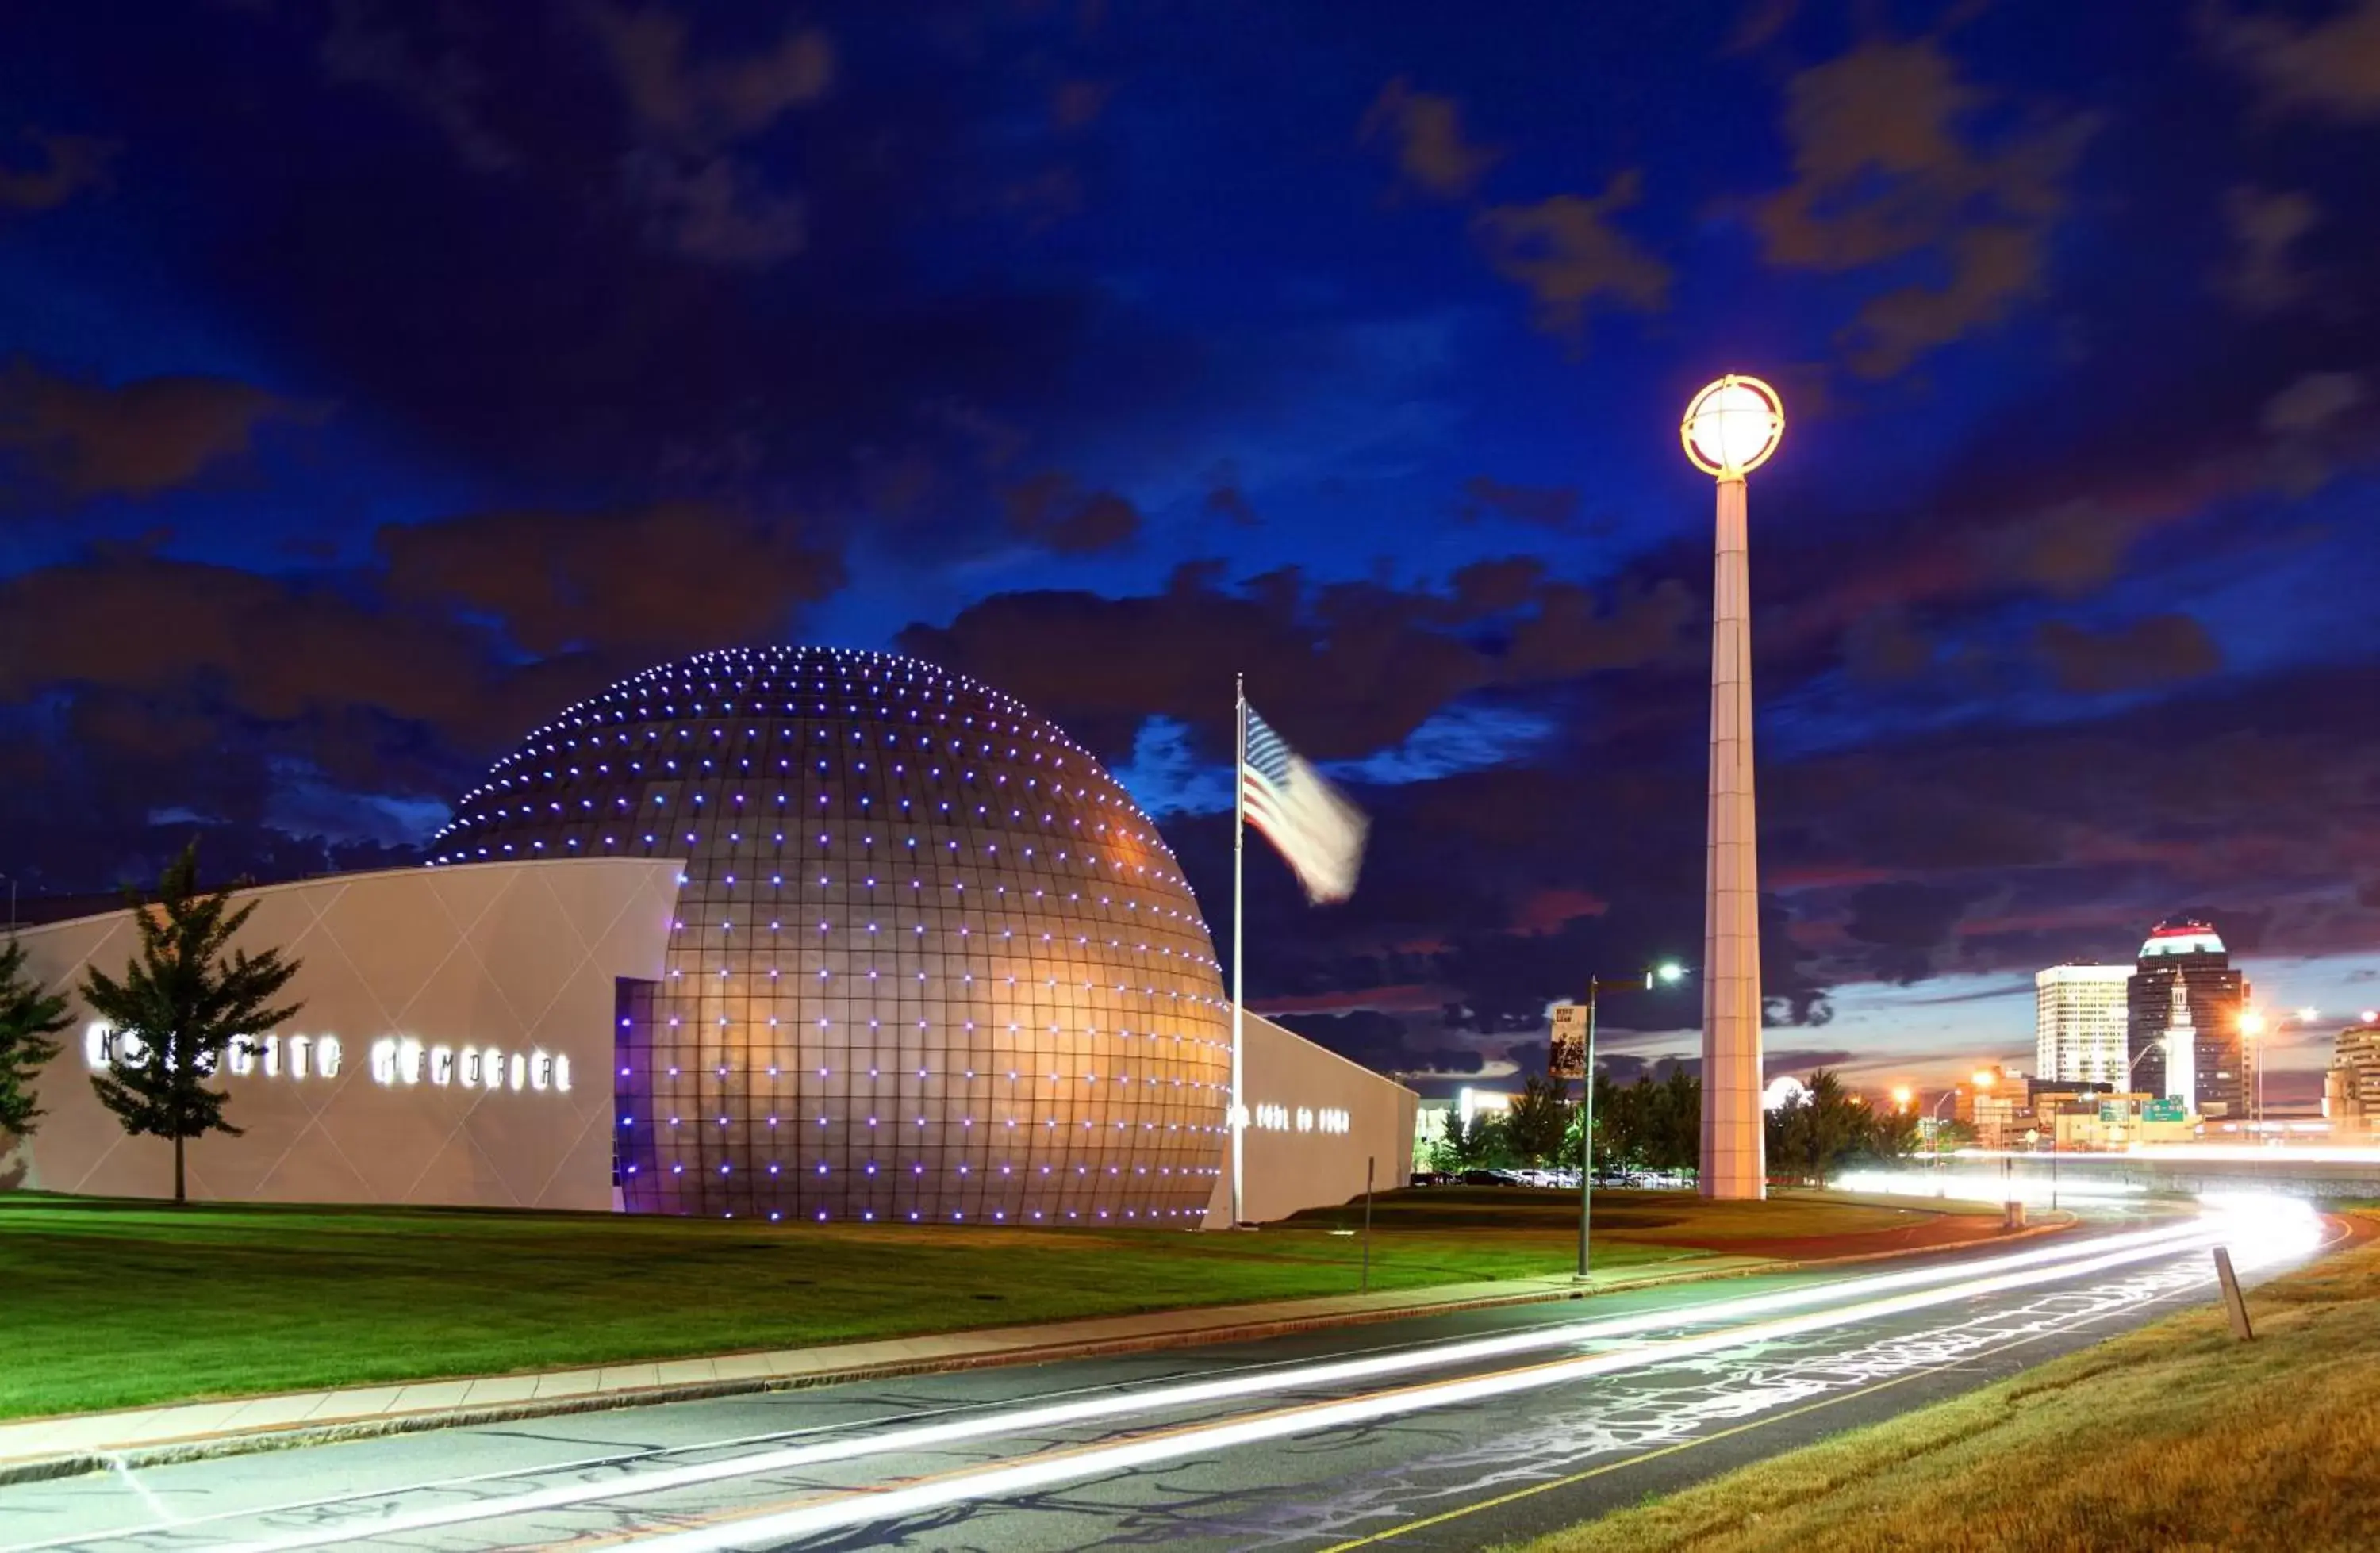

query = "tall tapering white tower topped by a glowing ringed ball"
[[1678, 376, 1785, 1198]]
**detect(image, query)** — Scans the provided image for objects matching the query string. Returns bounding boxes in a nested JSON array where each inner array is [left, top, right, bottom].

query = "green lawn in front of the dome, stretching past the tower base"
[[0, 1187, 1990, 1417]]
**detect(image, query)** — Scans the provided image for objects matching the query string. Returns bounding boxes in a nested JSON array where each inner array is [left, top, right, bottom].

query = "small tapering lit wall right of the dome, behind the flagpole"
[[1207, 1013, 1421, 1229]]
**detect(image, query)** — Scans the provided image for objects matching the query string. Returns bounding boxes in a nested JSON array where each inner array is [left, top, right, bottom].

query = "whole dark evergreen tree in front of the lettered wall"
[[83, 842, 302, 1203]]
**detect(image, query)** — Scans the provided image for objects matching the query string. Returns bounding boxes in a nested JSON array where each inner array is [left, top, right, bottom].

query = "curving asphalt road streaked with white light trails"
[[0, 1206, 2320, 1553]]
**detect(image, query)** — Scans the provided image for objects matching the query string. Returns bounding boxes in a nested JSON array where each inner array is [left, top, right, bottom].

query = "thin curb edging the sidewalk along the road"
[[0, 1213, 2080, 1489]]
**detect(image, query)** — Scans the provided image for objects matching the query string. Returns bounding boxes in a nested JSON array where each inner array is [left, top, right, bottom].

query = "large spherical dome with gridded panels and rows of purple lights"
[[431, 650, 1230, 1225]]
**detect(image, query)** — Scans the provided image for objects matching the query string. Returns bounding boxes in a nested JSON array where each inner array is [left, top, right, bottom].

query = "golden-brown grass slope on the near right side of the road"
[[1528, 1213, 2380, 1553]]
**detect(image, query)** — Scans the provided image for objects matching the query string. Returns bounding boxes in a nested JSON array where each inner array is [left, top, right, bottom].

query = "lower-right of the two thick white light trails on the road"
[[633, 1203, 2311, 1553]]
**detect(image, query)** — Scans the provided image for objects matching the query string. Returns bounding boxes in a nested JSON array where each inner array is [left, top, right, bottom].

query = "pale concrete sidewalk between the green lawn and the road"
[[0, 1215, 2073, 1484]]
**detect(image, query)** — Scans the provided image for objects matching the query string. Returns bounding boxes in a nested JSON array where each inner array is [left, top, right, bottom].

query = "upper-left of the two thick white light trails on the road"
[[200, 1203, 2285, 1553]]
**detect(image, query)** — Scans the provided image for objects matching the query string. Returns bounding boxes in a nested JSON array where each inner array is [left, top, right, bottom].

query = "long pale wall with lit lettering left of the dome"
[[0, 858, 681, 1210]]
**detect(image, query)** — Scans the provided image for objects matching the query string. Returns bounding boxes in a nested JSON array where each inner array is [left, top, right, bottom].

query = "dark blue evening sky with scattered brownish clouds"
[[0, 0, 2380, 1082]]
